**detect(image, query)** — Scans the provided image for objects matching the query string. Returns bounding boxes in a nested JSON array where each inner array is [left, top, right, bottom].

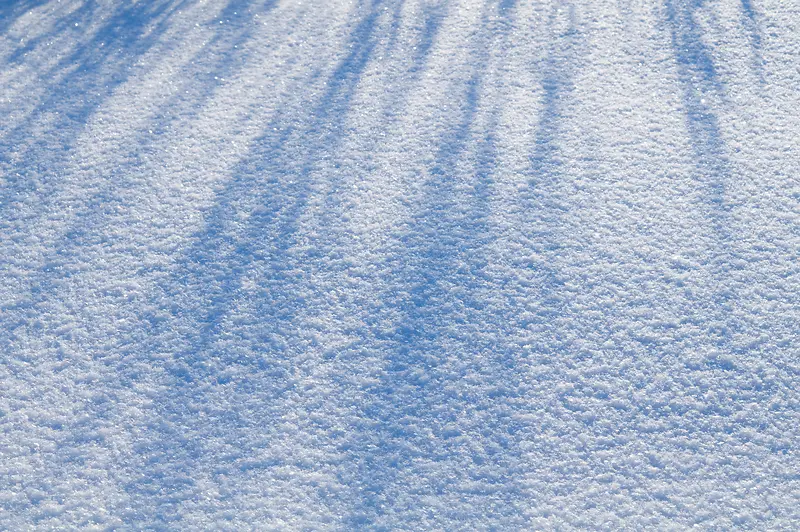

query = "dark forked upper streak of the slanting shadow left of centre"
[[167, 0, 396, 364]]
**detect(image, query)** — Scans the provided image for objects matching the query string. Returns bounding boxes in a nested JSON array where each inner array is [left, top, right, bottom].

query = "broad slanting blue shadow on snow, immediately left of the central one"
[[117, 0, 424, 524]]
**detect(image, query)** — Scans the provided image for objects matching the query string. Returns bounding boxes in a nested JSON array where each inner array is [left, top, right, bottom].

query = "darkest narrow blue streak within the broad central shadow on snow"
[[346, 76, 490, 527]]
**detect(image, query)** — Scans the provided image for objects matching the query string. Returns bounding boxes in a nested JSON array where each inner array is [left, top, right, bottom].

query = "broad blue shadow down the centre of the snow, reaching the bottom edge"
[[342, 1, 532, 530]]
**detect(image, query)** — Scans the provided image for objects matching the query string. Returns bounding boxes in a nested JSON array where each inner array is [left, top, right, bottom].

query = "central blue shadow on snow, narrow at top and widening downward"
[[345, 2, 532, 529]]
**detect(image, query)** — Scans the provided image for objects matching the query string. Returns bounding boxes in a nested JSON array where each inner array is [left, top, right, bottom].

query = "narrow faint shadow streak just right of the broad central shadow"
[[510, 1, 596, 460]]
